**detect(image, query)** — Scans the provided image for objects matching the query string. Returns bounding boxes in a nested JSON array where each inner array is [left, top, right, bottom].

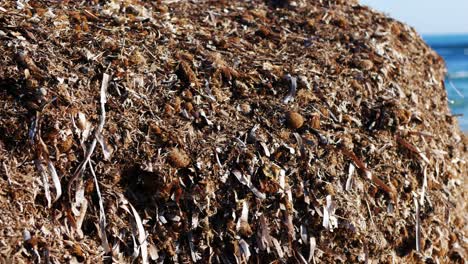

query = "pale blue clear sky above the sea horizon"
[[360, 0, 468, 34]]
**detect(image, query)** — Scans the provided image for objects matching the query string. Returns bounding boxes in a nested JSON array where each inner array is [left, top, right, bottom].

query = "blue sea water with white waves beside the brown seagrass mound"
[[423, 34, 468, 132]]
